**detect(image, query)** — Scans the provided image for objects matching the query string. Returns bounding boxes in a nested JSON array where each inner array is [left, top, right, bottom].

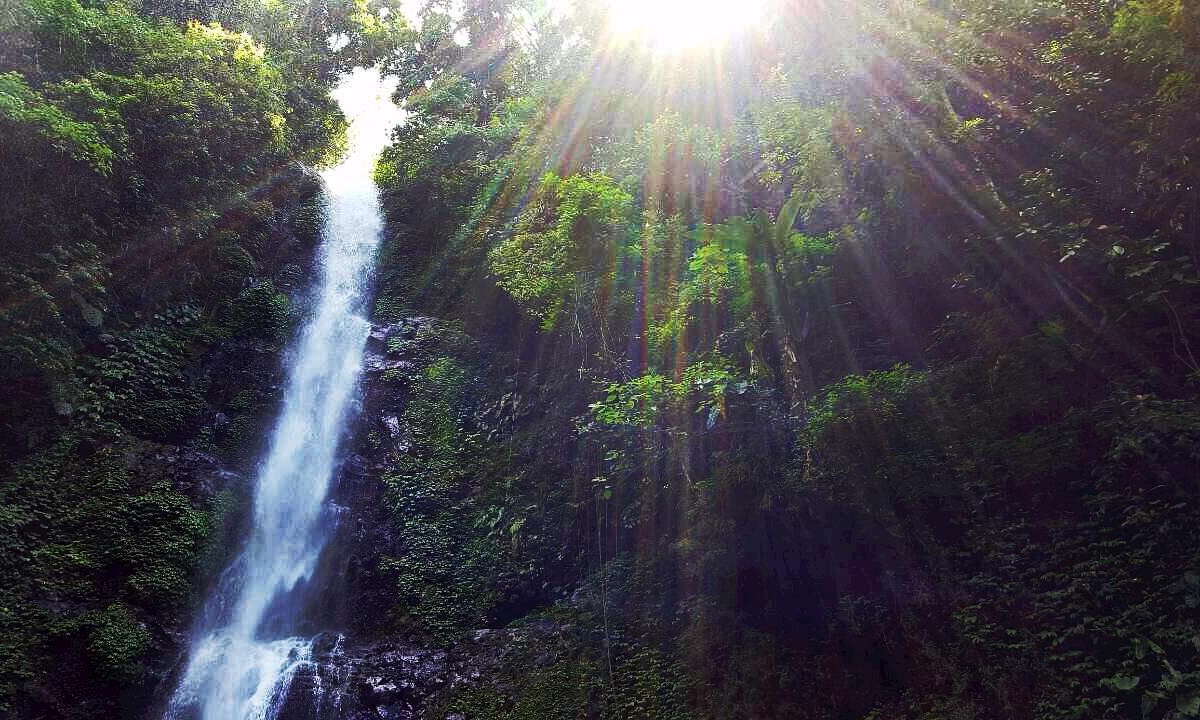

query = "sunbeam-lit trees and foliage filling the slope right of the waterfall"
[[369, 0, 1200, 719]]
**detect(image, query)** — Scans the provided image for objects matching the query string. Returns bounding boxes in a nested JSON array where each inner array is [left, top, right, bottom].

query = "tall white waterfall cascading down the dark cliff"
[[166, 68, 402, 720]]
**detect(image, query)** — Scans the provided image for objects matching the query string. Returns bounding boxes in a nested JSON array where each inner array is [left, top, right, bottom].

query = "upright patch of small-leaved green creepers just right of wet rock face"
[[382, 356, 540, 640]]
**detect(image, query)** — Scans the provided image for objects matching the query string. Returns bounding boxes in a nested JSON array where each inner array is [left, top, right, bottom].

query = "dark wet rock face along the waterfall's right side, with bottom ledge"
[[262, 317, 577, 720]]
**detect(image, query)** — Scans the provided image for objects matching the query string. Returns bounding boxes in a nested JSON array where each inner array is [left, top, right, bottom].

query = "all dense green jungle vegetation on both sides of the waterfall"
[[0, 0, 1200, 720]]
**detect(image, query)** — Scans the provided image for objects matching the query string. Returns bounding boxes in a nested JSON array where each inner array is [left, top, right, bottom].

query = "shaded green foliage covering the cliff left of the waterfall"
[[0, 0, 407, 718]]
